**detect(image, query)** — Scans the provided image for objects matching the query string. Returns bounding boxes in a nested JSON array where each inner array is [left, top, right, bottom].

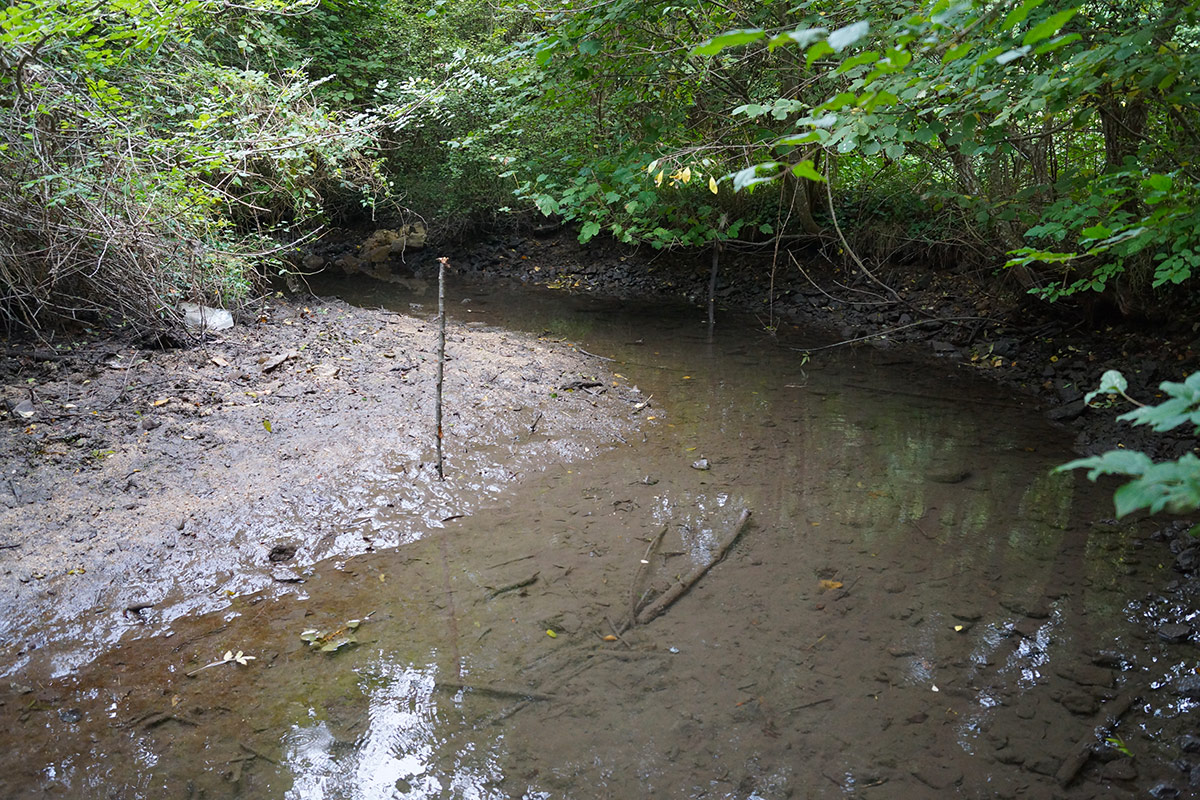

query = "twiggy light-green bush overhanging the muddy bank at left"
[[0, 0, 396, 329]]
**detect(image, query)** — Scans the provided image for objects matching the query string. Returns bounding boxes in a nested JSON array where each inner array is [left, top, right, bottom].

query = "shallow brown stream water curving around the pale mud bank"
[[0, 278, 1189, 800]]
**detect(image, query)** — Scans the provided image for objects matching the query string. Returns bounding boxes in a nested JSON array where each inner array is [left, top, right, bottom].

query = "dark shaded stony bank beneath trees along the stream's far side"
[[310, 228, 1200, 457]]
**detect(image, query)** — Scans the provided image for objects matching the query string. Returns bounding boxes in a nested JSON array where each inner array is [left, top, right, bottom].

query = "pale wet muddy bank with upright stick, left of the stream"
[[0, 297, 641, 675]]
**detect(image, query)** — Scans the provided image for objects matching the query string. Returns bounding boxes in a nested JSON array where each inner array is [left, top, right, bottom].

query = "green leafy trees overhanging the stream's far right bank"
[[446, 0, 1200, 305]]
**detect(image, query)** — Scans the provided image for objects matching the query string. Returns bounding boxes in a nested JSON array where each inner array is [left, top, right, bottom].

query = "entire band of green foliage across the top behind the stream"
[[0, 0, 1200, 325]]
